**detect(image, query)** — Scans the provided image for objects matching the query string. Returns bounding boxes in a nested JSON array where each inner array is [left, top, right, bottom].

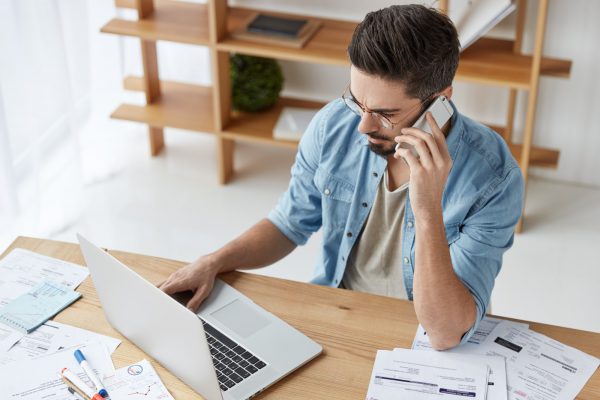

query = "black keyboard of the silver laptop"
[[200, 318, 267, 392]]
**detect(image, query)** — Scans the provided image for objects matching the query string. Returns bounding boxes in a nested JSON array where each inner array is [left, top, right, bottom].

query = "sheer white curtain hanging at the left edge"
[[0, 0, 90, 245]]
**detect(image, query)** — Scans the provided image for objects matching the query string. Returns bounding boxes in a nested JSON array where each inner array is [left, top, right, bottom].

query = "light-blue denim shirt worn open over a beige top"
[[269, 99, 523, 342]]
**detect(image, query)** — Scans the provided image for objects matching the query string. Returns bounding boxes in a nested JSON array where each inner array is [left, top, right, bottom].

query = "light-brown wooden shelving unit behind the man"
[[102, 0, 571, 231]]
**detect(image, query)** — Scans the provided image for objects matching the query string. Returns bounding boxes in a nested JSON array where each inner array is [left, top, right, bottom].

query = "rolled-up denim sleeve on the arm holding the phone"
[[450, 167, 524, 344]]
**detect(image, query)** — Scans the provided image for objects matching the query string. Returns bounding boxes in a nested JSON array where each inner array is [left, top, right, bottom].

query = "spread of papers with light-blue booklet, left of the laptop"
[[0, 249, 173, 400]]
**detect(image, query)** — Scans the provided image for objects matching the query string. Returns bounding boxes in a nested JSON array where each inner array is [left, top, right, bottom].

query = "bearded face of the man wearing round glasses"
[[350, 66, 422, 156]]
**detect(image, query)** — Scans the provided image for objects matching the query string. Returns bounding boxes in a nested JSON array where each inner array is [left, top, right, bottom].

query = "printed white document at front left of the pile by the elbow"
[[367, 349, 489, 400]]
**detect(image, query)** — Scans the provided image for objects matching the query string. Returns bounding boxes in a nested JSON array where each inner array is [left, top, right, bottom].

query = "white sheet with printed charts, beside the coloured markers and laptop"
[[102, 360, 173, 400]]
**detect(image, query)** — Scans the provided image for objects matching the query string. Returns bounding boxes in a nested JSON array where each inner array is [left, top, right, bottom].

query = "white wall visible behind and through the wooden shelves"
[[117, 0, 600, 186]]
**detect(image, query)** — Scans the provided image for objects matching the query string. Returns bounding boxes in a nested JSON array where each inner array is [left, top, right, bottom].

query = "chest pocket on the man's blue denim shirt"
[[314, 169, 354, 230]]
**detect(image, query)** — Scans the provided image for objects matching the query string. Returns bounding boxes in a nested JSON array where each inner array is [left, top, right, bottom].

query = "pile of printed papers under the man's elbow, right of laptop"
[[367, 317, 600, 400]]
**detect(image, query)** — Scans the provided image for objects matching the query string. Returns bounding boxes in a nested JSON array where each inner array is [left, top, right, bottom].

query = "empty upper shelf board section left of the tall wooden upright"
[[101, 0, 209, 45]]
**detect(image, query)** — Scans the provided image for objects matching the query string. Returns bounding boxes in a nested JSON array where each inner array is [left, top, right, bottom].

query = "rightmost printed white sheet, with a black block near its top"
[[482, 322, 600, 400]]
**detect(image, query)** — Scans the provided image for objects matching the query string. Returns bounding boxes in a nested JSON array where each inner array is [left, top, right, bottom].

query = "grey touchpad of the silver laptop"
[[210, 299, 269, 338]]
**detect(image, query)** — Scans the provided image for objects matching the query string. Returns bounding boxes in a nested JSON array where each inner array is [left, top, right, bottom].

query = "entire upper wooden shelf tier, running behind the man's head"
[[102, 4, 571, 90]]
